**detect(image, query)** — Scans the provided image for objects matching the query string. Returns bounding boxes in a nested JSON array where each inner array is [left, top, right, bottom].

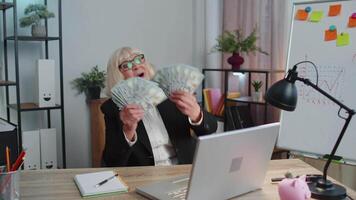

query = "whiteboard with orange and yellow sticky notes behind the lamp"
[[277, 0, 356, 163]]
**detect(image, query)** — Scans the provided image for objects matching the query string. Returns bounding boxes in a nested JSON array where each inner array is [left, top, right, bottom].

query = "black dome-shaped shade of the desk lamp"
[[265, 79, 298, 111]]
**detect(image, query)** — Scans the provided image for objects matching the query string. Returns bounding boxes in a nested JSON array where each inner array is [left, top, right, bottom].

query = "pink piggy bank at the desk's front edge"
[[278, 176, 311, 200]]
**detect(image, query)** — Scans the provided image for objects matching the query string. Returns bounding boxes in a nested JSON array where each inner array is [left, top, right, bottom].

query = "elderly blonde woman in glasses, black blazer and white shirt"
[[101, 47, 217, 167]]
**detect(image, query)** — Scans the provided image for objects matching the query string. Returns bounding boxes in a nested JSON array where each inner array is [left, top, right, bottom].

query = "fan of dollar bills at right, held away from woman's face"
[[153, 64, 204, 96]]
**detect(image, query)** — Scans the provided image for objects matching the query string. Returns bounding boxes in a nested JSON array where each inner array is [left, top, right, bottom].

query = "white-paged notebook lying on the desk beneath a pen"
[[74, 171, 128, 197]]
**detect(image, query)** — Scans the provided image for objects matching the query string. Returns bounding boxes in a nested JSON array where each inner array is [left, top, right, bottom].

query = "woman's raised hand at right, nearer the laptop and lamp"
[[169, 91, 202, 122]]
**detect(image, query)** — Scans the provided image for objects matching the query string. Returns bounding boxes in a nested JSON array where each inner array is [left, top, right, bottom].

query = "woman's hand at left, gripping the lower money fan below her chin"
[[119, 104, 144, 141]]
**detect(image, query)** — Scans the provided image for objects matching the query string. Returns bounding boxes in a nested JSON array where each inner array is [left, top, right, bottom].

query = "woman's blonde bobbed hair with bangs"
[[106, 47, 155, 97]]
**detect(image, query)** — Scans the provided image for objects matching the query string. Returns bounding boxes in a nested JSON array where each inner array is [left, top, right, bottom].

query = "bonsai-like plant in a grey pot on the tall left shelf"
[[20, 4, 54, 37]]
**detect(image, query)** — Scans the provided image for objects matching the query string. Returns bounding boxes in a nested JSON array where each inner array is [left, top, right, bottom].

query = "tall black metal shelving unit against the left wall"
[[0, 0, 66, 168]]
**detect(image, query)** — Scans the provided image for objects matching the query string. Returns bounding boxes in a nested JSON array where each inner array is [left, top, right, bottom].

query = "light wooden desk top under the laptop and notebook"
[[20, 159, 356, 200]]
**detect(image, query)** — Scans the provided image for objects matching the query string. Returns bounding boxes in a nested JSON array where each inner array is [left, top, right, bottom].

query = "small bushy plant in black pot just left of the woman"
[[71, 66, 106, 100]]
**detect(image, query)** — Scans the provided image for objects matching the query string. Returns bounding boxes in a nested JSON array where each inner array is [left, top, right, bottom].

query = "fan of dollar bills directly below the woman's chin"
[[111, 77, 167, 110]]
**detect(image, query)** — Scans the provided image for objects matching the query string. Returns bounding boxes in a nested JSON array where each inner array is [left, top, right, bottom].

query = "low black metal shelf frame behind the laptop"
[[202, 68, 284, 130]]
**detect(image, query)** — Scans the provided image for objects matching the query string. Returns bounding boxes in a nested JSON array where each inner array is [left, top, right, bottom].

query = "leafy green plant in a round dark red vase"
[[214, 28, 268, 70]]
